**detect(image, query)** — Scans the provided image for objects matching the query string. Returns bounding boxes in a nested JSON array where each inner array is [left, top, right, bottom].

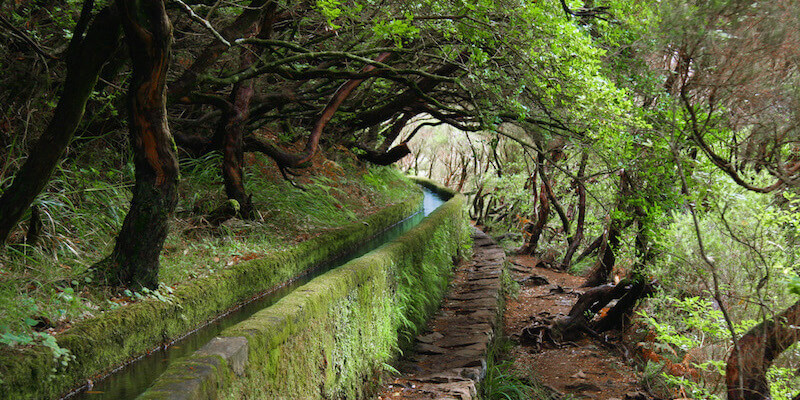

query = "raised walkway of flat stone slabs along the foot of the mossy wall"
[[378, 229, 506, 400]]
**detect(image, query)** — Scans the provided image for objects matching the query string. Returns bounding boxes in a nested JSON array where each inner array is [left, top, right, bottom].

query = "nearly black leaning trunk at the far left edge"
[[0, 8, 120, 244]]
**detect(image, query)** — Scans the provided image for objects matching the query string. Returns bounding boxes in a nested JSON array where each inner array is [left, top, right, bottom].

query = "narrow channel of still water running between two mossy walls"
[[70, 187, 445, 400]]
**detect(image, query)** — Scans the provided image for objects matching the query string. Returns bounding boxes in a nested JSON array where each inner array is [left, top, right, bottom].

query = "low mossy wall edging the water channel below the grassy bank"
[[0, 188, 422, 399]]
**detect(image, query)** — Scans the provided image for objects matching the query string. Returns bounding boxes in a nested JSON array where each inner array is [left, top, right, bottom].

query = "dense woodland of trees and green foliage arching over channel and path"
[[0, 0, 800, 399]]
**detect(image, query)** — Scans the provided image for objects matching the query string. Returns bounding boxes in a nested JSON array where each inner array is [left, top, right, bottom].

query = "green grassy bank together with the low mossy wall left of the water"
[[0, 148, 419, 397]]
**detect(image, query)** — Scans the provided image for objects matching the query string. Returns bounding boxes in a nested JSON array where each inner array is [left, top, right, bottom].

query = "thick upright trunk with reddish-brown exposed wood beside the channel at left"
[[107, 0, 178, 288]]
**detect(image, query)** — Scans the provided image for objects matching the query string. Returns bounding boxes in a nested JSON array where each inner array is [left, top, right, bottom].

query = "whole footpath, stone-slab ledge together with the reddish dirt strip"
[[376, 234, 652, 400]]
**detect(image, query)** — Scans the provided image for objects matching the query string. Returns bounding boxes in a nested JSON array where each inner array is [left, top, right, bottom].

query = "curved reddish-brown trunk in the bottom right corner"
[[725, 301, 800, 400]]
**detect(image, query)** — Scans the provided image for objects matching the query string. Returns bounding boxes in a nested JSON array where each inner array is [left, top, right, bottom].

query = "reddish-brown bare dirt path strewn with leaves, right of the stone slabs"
[[504, 256, 649, 400]]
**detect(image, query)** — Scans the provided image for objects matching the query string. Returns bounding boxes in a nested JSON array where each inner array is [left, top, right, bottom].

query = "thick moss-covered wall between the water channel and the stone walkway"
[[140, 180, 470, 399]]
